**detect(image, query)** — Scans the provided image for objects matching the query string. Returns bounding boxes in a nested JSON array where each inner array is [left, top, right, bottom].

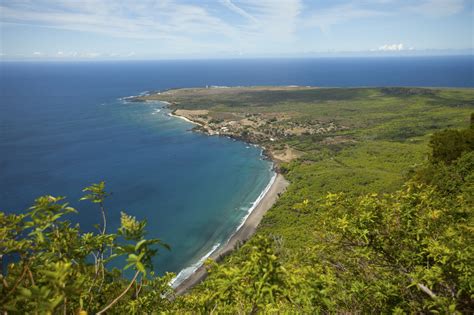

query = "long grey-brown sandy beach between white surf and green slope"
[[175, 174, 289, 295]]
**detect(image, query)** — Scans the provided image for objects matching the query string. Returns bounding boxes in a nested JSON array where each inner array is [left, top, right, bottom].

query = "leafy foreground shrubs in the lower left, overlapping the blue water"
[[0, 182, 172, 314]]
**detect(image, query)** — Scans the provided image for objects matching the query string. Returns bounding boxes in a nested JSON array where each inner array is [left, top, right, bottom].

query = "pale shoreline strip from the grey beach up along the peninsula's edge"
[[165, 108, 289, 295]]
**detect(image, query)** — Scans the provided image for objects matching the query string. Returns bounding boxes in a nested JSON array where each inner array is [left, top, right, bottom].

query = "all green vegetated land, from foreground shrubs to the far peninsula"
[[0, 88, 474, 314]]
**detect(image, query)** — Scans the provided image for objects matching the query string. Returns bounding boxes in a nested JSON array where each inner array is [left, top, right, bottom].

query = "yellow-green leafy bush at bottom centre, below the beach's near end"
[[178, 236, 298, 314]]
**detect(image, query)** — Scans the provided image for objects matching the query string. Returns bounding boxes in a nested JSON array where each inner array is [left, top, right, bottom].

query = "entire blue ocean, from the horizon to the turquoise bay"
[[0, 56, 474, 282]]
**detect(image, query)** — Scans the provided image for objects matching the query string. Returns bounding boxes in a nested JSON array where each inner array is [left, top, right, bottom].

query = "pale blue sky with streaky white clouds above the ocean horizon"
[[0, 0, 474, 60]]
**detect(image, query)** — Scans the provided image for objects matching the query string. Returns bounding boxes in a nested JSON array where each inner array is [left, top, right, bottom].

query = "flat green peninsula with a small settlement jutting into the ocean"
[[131, 86, 474, 169]]
